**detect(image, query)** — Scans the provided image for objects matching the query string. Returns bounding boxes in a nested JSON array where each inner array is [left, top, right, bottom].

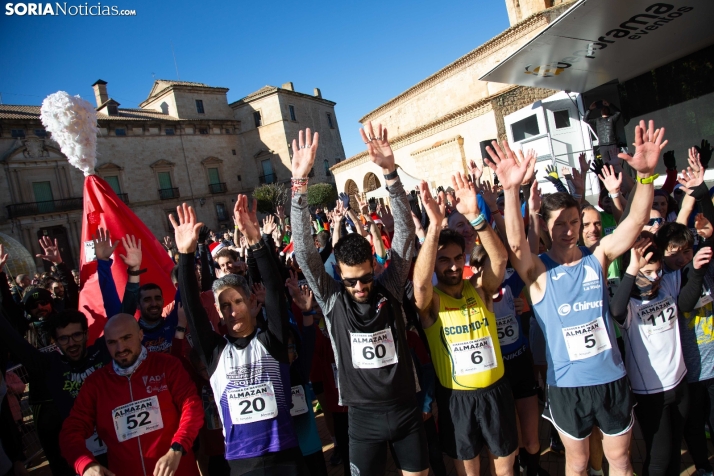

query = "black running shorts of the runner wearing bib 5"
[[543, 377, 635, 440]]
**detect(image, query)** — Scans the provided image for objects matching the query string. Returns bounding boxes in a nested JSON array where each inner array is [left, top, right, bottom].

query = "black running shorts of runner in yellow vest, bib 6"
[[436, 378, 518, 460]]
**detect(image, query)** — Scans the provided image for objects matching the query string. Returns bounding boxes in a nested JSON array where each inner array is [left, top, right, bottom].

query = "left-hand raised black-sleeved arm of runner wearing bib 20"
[[169, 203, 223, 363]]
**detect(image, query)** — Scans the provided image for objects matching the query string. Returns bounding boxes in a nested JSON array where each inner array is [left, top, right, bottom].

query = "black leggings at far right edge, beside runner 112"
[[684, 379, 714, 473]]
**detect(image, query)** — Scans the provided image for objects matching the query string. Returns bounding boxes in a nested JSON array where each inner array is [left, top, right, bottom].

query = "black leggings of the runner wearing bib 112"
[[635, 381, 689, 476]]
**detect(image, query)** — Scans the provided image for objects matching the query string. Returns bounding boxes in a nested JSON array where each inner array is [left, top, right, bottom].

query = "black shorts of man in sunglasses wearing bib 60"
[[348, 400, 429, 476]]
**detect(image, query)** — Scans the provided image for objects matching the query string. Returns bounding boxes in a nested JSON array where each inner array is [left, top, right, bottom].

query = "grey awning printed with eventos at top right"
[[479, 0, 714, 93]]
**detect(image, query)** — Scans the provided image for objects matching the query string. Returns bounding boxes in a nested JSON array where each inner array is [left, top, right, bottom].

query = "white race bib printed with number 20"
[[226, 382, 278, 425]]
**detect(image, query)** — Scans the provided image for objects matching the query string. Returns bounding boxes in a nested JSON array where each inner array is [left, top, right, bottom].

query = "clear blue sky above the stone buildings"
[[0, 0, 508, 157]]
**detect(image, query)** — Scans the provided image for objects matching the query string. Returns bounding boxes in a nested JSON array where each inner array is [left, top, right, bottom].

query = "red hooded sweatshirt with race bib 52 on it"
[[60, 352, 203, 476]]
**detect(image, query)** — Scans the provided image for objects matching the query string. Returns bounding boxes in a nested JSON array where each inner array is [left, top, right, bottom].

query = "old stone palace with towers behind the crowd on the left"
[[0, 80, 345, 269]]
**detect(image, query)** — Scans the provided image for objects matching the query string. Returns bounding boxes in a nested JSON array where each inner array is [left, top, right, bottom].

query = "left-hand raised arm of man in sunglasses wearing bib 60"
[[290, 129, 340, 314]]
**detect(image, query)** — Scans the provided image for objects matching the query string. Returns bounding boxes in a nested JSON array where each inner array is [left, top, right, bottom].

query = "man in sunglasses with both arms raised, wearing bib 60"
[[291, 122, 429, 476]]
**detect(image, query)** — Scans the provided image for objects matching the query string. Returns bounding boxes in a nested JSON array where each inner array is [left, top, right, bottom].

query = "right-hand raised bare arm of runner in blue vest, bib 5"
[[593, 121, 667, 270]]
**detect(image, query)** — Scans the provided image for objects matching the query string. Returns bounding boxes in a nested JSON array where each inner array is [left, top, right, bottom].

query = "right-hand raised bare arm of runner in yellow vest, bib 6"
[[451, 172, 506, 299]]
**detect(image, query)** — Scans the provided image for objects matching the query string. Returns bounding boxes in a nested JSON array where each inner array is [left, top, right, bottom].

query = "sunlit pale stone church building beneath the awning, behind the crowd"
[[332, 0, 570, 193]]
